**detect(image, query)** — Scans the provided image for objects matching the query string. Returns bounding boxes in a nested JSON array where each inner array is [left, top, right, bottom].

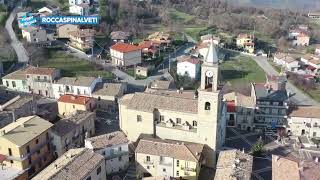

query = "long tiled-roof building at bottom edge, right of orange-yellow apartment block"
[[32, 148, 107, 180]]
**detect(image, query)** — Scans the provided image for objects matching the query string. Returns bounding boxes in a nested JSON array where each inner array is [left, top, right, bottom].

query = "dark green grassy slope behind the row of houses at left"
[[40, 52, 113, 79]]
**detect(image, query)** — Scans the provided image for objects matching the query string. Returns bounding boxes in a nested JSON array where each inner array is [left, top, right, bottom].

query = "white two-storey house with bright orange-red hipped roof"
[[110, 42, 142, 66]]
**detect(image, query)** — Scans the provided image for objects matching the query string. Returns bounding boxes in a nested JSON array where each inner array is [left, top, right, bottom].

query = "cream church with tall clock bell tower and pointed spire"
[[119, 44, 226, 166]]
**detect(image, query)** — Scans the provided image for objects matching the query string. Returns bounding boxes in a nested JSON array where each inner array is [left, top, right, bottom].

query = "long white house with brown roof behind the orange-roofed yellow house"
[[52, 76, 102, 99]]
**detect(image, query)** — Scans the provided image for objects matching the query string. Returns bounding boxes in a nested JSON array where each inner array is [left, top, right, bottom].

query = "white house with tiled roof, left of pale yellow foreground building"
[[85, 131, 129, 174]]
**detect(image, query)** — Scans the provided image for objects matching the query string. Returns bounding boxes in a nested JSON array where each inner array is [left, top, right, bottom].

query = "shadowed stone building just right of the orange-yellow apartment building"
[[50, 111, 96, 157]]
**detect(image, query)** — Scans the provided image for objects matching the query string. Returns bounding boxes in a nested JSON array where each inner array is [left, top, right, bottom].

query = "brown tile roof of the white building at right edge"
[[288, 106, 320, 118]]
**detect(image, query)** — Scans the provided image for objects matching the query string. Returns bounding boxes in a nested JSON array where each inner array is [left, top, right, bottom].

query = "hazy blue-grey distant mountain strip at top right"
[[227, 0, 320, 11]]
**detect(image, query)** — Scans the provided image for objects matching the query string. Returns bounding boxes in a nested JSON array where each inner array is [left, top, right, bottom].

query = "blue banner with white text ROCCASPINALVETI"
[[40, 16, 100, 25]]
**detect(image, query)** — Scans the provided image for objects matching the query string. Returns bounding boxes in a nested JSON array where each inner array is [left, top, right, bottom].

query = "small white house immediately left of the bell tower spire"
[[177, 55, 200, 79]]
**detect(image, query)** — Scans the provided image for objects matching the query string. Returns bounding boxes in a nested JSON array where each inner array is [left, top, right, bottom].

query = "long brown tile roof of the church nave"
[[122, 91, 198, 114]]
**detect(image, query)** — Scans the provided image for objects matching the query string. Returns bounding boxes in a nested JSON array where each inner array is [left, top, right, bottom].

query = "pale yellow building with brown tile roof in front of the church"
[[135, 138, 204, 180]]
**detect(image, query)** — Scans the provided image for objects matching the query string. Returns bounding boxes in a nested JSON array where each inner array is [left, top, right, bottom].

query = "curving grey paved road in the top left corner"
[[5, 8, 29, 63]]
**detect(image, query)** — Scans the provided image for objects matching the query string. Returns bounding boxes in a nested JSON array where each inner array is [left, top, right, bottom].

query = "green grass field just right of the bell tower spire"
[[221, 56, 266, 87]]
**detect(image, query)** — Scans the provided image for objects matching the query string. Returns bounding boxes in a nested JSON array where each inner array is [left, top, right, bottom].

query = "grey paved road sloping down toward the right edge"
[[250, 56, 320, 105]]
